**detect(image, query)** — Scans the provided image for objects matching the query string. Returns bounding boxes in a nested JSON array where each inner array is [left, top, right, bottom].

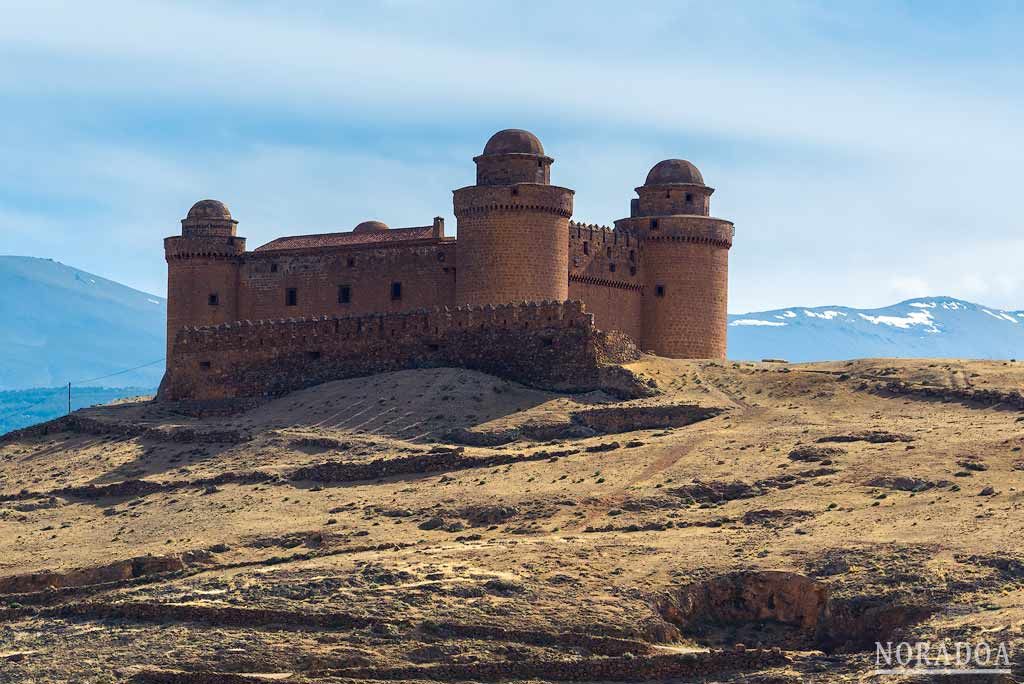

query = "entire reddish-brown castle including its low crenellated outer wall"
[[162, 130, 734, 398]]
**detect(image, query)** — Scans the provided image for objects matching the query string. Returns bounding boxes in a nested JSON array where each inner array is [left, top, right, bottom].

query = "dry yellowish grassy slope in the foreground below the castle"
[[0, 357, 1024, 682]]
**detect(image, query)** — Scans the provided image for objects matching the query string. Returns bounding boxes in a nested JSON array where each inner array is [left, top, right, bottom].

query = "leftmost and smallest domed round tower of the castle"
[[164, 200, 246, 359]]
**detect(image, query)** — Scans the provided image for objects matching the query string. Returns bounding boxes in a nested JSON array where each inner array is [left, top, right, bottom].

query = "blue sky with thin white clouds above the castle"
[[0, 0, 1024, 312]]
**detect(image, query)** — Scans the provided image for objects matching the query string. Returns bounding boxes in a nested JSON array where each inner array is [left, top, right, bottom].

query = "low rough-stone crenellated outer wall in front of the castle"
[[159, 302, 644, 400]]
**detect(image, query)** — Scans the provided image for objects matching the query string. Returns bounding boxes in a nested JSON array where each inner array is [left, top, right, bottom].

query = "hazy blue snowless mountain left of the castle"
[[0, 256, 167, 390]]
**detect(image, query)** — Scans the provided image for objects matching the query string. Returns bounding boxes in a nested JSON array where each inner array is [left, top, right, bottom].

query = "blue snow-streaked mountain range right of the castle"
[[729, 297, 1024, 361]]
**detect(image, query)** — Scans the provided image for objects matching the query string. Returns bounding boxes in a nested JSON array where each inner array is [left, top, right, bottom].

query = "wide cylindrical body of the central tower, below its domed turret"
[[455, 183, 572, 305]]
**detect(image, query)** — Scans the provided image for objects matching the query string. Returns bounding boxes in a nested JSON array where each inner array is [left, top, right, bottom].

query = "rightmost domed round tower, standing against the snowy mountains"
[[615, 159, 734, 358]]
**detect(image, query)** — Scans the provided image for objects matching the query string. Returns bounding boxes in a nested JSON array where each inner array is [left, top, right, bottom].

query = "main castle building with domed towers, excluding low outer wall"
[[157, 130, 734, 398]]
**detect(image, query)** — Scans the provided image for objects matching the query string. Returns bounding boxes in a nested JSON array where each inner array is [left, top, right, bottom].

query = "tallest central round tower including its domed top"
[[454, 129, 572, 304]]
